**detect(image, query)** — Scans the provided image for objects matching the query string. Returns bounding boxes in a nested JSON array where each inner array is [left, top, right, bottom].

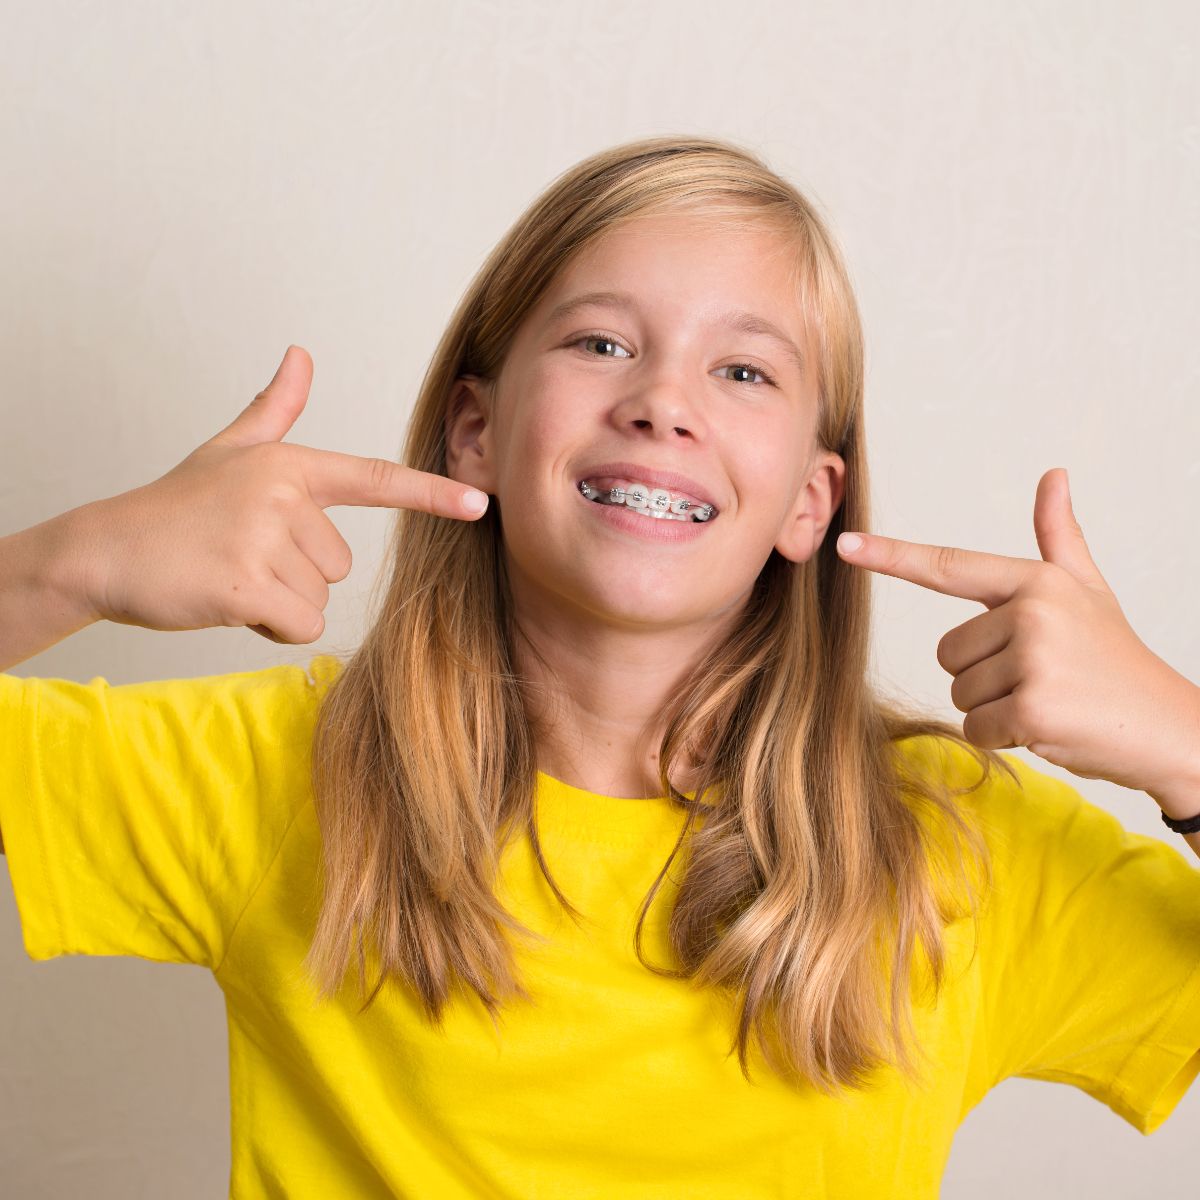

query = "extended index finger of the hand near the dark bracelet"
[[838, 534, 1036, 608]]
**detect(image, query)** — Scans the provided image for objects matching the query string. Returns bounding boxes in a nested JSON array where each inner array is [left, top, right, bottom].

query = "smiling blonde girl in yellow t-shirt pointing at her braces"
[[0, 138, 1200, 1200]]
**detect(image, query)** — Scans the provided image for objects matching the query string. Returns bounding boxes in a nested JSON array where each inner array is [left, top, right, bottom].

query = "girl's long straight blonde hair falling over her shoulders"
[[306, 137, 1016, 1092]]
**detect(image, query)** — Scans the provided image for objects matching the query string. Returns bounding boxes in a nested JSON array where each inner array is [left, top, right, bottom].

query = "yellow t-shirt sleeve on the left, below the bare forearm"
[[0, 666, 338, 971]]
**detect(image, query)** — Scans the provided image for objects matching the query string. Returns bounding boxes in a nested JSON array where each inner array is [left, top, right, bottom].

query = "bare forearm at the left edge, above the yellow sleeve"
[[0, 509, 100, 671]]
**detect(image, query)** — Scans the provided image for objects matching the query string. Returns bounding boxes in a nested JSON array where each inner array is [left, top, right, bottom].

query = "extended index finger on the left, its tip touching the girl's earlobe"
[[293, 446, 487, 521]]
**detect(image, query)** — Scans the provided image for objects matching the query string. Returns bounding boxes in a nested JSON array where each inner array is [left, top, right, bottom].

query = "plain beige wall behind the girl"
[[0, 0, 1200, 1200]]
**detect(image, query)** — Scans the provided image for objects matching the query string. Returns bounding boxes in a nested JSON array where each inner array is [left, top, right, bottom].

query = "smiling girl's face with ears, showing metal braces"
[[448, 214, 845, 628]]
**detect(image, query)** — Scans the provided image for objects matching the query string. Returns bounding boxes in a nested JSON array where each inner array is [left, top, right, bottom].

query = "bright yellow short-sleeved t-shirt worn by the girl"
[[0, 655, 1200, 1200]]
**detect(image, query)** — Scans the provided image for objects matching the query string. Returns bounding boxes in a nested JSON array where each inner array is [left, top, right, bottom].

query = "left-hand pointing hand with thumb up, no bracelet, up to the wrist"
[[72, 346, 487, 642]]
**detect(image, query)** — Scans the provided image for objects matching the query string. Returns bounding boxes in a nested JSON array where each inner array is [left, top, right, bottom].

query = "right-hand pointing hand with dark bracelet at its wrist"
[[839, 468, 1200, 792]]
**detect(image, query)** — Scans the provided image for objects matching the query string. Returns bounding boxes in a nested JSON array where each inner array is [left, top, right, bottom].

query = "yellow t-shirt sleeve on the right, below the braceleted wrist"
[[958, 751, 1200, 1134]]
